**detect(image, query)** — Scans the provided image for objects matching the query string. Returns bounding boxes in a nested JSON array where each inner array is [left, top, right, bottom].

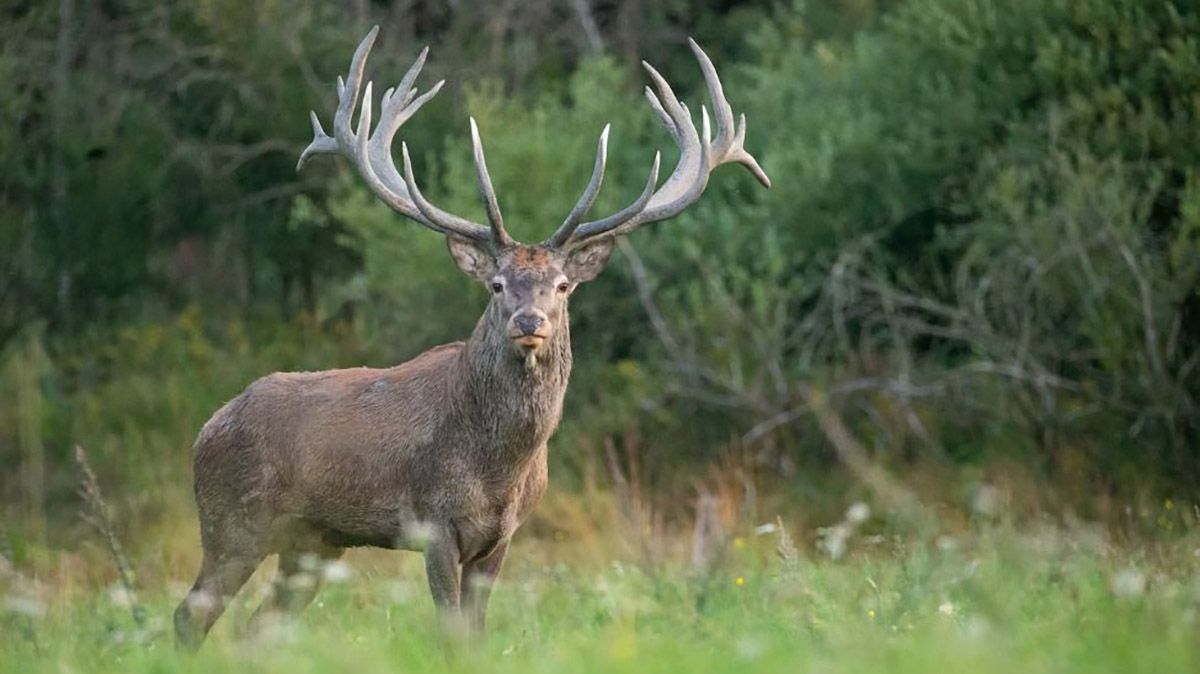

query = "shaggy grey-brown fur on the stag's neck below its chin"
[[463, 298, 571, 468]]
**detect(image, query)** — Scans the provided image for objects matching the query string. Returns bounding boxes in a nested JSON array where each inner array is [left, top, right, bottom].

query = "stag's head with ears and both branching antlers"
[[296, 26, 770, 362]]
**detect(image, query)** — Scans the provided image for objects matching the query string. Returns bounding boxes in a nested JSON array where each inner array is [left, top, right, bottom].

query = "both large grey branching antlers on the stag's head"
[[296, 26, 770, 251]]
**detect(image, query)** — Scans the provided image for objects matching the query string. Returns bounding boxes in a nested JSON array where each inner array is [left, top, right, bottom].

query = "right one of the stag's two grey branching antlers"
[[544, 38, 770, 248]]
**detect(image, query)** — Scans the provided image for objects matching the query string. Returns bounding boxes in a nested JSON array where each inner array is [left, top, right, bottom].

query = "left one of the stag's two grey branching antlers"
[[296, 26, 512, 248]]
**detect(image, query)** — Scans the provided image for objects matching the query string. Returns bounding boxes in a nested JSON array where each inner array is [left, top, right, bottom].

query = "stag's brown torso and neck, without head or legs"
[[194, 304, 570, 561]]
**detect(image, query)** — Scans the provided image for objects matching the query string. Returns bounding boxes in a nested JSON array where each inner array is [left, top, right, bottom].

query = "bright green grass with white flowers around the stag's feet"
[[0, 525, 1200, 674]]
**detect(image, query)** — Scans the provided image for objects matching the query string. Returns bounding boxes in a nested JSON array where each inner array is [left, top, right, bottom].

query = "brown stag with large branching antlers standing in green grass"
[[174, 26, 770, 650]]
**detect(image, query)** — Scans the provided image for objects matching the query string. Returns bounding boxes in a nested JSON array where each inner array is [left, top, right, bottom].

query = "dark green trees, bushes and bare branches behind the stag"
[[0, 0, 1200, 555]]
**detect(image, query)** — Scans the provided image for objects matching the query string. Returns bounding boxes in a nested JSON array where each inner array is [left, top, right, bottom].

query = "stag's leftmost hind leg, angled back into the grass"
[[175, 550, 264, 650]]
